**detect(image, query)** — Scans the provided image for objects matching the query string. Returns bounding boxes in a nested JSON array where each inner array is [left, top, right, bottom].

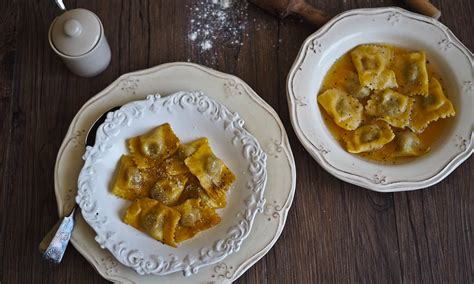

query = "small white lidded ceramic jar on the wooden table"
[[48, 9, 110, 77]]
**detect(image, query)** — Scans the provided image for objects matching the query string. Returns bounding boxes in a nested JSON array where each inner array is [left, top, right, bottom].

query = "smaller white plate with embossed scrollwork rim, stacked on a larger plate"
[[76, 91, 267, 276]]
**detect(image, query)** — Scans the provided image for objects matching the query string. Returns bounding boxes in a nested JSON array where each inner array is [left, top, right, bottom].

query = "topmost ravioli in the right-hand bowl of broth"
[[351, 45, 398, 90]]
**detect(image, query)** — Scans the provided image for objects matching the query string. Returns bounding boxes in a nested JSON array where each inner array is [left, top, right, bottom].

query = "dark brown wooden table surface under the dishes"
[[0, 0, 474, 284]]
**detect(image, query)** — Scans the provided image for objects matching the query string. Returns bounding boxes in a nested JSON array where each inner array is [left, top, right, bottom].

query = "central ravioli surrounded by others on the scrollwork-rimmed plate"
[[150, 175, 188, 206]]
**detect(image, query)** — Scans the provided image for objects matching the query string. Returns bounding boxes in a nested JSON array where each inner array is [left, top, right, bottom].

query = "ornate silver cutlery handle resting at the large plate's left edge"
[[43, 208, 76, 264]]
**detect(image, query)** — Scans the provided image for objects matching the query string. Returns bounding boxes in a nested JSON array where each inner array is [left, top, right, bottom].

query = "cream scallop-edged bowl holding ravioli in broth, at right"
[[287, 8, 474, 192]]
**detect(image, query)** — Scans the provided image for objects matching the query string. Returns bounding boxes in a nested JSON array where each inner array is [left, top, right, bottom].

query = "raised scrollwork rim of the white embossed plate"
[[76, 91, 267, 276]]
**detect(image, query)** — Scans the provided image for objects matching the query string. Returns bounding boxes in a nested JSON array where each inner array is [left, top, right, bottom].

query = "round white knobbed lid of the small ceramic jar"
[[50, 9, 102, 56]]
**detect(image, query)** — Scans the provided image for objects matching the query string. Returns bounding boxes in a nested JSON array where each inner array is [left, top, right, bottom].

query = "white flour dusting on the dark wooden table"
[[187, 0, 248, 52]]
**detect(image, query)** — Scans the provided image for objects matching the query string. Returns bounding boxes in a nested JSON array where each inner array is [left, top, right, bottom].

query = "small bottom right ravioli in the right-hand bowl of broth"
[[393, 130, 430, 157]]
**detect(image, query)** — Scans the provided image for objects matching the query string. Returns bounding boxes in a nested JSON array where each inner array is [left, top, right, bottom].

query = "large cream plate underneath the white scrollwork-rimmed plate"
[[55, 63, 296, 283]]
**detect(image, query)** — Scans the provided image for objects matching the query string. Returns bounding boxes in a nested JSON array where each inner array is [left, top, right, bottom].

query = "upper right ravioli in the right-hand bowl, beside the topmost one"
[[394, 52, 428, 96]]
